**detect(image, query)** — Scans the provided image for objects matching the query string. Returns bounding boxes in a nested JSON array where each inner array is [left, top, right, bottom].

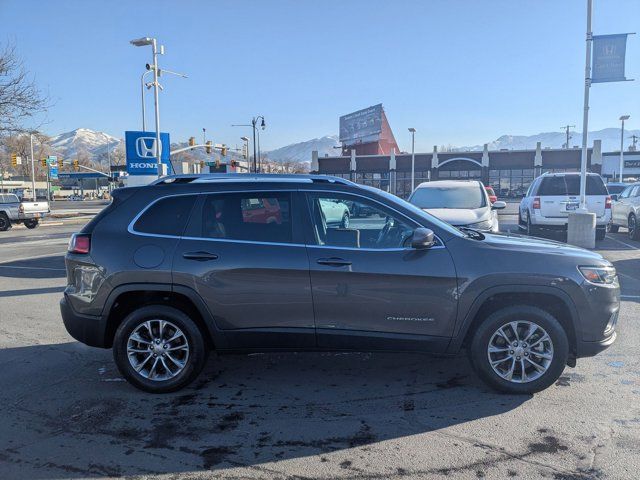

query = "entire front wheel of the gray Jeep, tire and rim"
[[469, 305, 569, 394]]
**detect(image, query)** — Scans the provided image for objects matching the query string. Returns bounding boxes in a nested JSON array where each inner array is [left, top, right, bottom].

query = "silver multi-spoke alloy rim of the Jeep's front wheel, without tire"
[[487, 320, 553, 383]]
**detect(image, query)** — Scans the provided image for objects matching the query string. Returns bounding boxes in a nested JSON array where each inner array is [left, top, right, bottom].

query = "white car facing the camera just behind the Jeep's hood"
[[409, 180, 507, 232]]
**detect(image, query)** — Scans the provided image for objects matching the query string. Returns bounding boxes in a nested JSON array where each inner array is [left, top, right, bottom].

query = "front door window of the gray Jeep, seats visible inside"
[[308, 193, 414, 249]]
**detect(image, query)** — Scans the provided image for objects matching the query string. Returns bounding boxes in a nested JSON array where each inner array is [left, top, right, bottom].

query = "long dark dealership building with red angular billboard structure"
[[311, 105, 640, 198]]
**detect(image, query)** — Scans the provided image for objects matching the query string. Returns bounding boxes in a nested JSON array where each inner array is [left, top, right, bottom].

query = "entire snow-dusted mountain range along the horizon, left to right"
[[42, 128, 640, 167]]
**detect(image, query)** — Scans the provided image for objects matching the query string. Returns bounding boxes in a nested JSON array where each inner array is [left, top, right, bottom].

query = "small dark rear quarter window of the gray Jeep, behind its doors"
[[133, 195, 196, 237]]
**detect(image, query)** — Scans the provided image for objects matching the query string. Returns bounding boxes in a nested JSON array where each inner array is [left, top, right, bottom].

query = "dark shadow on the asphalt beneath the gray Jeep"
[[0, 343, 531, 478]]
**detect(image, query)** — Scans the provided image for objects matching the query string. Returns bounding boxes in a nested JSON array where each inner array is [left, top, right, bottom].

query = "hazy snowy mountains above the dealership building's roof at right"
[[454, 128, 640, 152]]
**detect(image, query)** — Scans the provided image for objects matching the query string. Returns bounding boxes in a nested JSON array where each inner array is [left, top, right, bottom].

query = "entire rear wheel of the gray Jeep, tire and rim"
[[113, 305, 208, 393]]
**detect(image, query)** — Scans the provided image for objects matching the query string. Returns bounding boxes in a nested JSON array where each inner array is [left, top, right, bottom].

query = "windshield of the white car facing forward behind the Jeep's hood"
[[409, 183, 486, 209]]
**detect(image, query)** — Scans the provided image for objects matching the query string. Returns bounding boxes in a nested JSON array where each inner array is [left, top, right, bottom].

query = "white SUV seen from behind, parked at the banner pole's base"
[[518, 173, 611, 240]]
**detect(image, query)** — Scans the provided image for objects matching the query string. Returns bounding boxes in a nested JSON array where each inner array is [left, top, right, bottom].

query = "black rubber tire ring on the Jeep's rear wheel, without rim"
[[113, 305, 209, 393]]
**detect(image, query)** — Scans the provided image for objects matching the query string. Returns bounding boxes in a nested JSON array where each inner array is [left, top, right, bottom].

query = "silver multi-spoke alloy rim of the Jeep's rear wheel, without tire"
[[127, 319, 189, 382]]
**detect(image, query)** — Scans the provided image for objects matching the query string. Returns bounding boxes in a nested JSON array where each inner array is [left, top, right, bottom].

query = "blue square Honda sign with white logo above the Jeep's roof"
[[124, 132, 171, 175]]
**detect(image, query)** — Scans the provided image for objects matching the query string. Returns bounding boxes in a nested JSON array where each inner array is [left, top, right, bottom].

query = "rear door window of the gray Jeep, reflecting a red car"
[[196, 192, 292, 243]]
